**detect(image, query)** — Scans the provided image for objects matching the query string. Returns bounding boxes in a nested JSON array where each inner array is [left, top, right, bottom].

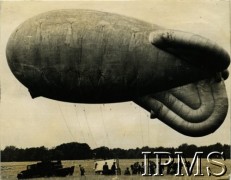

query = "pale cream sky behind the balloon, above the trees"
[[0, 0, 231, 149]]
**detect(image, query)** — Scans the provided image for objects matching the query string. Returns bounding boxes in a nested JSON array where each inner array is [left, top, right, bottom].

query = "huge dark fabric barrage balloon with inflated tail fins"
[[6, 10, 230, 136]]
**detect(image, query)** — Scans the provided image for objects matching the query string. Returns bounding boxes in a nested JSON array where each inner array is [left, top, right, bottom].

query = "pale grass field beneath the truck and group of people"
[[1, 159, 231, 180]]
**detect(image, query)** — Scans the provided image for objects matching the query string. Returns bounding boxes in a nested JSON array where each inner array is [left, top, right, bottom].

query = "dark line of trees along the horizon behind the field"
[[1, 142, 230, 162]]
